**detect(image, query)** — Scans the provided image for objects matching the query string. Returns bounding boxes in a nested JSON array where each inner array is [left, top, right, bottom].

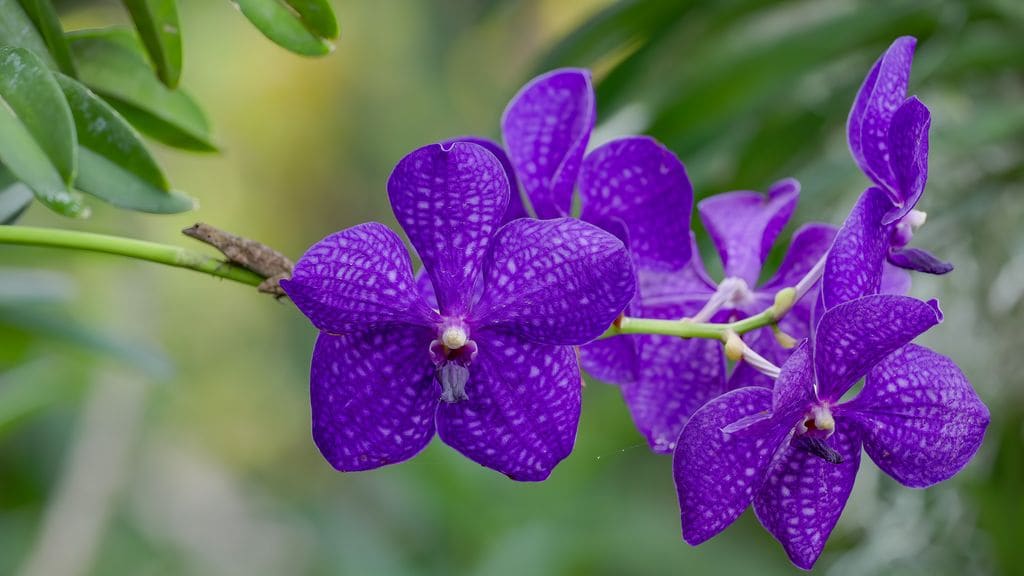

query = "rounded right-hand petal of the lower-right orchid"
[[841, 344, 989, 488]]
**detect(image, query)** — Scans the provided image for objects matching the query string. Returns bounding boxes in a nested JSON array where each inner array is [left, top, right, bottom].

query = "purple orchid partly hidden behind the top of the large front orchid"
[[451, 68, 693, 271]]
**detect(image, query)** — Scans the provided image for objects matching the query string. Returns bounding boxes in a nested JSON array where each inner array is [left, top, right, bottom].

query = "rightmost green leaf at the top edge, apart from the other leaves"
[[237, 0, 338, 56]]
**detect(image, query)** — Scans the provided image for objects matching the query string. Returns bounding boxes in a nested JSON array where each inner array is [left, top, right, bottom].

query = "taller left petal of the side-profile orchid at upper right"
[[847, 36, 918, 189]]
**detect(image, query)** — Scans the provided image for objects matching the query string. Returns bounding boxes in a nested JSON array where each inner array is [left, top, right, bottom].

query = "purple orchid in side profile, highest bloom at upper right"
[[847, 36, 953, 276]]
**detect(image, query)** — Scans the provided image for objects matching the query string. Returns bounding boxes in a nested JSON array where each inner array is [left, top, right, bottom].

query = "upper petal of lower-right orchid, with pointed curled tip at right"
[[814, 294, 942, 403]]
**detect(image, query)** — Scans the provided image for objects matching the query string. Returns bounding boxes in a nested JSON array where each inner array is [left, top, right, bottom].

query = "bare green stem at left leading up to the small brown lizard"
[[0, 225, 263, 286]]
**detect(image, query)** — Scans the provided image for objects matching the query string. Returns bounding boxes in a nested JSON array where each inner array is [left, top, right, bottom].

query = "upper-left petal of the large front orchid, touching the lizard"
[[281, 222, 436, 334]]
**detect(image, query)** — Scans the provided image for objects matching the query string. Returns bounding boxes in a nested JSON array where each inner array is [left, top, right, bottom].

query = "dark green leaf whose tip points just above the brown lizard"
[[57, 76, 195, 214]]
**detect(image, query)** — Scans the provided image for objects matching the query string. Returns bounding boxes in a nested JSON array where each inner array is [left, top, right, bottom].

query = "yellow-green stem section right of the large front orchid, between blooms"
[[601, 288, 797, 342]]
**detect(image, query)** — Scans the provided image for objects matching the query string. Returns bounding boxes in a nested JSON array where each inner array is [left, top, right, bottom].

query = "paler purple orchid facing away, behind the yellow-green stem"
[[581, 179, 835, 453]]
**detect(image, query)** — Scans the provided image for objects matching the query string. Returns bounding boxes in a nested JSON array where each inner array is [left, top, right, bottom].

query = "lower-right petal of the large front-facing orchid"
[[437, 330, 583, 482]]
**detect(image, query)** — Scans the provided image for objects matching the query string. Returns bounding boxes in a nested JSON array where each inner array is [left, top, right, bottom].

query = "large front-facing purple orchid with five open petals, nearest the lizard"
[[282, 142, 635, 481]]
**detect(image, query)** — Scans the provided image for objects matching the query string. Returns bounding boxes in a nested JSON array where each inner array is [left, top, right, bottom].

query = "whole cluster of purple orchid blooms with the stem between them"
[[282, 37, 989, 569]]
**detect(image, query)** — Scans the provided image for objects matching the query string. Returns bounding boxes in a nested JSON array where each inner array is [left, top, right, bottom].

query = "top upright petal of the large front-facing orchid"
[[387, 142, 509, 316]]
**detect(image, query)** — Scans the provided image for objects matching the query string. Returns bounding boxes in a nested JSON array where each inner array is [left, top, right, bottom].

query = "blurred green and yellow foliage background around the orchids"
[[0, 0, 1024, 576]]
